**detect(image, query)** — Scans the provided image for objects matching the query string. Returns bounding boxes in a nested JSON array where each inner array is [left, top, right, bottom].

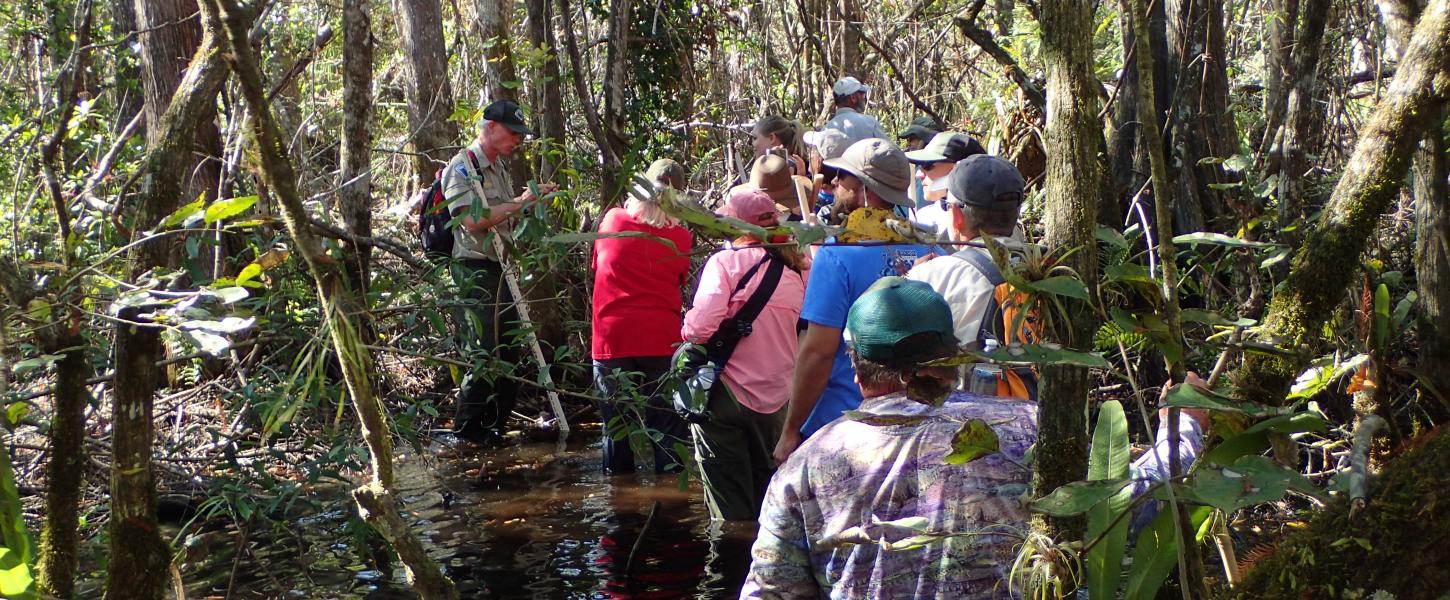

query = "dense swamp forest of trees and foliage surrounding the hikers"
[[0, 0, 1450, 599]]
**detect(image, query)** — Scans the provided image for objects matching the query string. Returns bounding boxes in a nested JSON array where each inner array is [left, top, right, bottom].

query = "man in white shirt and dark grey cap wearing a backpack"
[[906, 154, 1027, 349]]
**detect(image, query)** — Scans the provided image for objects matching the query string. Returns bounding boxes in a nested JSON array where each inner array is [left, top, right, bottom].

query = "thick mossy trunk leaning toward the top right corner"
[[1237, 0, 1450, 404]]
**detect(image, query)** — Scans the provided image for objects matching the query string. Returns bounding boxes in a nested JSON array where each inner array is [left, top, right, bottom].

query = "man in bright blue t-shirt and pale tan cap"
[[774, 138, 929, 464]]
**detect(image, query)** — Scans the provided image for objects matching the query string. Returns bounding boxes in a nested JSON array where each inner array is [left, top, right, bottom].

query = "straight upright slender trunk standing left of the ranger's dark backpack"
[[338, 0, 373, 297]]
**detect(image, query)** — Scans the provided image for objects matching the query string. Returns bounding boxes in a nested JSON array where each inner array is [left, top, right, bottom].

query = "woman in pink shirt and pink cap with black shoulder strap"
[[682, 187, 809, 520]]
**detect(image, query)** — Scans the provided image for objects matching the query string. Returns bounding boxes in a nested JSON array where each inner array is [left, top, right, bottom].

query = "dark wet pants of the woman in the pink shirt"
[[690, 380, 786, 520]]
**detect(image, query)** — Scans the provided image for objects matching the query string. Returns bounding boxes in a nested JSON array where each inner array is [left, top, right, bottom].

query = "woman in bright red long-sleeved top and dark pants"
[[590, 159, 692, 474]]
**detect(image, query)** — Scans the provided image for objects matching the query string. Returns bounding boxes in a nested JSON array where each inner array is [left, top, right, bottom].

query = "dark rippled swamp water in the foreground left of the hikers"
[[187, 432, 755, 599]]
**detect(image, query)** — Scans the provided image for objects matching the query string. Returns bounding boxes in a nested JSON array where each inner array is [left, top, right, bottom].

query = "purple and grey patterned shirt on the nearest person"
[[741, 393, 1037, 599]]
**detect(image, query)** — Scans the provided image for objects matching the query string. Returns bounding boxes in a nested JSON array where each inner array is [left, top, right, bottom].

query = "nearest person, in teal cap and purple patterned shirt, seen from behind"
[[741, 277, 1206, 599]]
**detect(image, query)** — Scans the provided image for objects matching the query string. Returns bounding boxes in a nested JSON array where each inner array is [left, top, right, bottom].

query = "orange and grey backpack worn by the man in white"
[[953, 248, 1043, 401]]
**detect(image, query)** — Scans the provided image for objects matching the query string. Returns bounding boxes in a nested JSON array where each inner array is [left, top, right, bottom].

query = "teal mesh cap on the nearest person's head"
[[845, 277, 957, 368]]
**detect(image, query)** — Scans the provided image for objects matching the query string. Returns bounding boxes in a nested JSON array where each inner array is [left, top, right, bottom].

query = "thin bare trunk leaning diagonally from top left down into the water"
[[203, 0, 458, 600]]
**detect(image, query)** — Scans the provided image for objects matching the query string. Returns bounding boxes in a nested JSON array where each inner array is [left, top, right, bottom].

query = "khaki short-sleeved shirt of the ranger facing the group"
[[444, 141, 513, 261]]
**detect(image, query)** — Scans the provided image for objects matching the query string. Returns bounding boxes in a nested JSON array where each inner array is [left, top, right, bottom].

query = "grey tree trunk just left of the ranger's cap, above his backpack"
[[394, 0, 458, 186]]
